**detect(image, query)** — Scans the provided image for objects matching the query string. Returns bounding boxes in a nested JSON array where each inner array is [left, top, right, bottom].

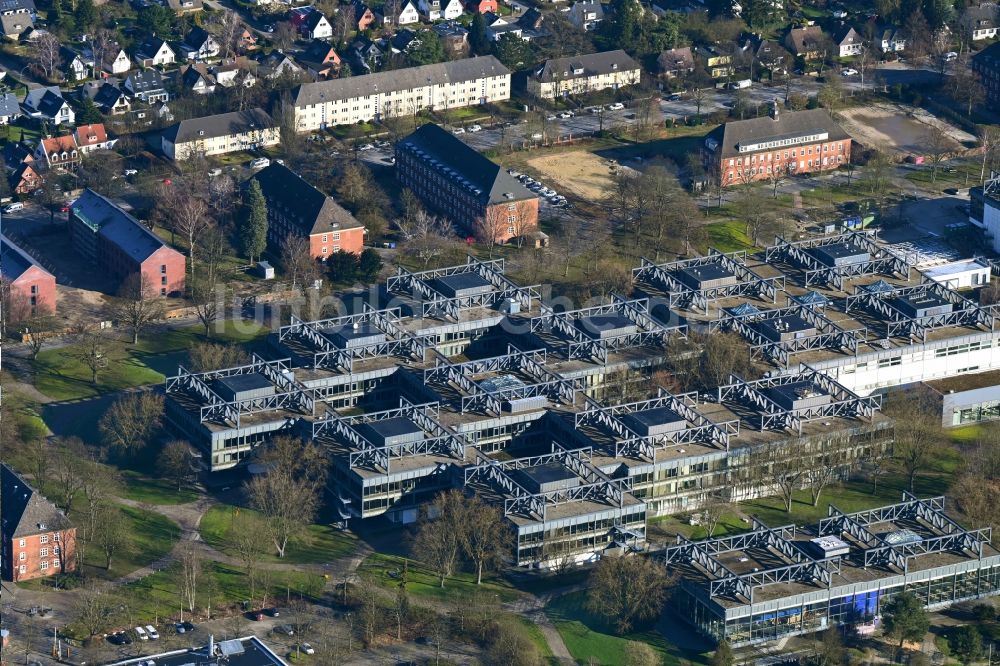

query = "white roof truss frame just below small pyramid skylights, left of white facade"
[[708, 305, 864, 368]]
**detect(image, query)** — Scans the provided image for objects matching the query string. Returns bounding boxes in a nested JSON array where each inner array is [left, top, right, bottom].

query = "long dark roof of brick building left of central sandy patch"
[[400, 123, 537, 204]]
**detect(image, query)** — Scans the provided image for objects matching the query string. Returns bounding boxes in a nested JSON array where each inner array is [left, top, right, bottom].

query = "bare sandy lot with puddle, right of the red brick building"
[[839, 104, 976, 155]]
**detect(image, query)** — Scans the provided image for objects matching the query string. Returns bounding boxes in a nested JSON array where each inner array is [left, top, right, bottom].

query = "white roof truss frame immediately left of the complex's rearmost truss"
[[632, 248, 785, 313]]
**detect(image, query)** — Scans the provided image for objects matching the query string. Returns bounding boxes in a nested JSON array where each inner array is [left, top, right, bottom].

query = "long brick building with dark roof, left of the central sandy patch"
[[396, 123, 538, 243]]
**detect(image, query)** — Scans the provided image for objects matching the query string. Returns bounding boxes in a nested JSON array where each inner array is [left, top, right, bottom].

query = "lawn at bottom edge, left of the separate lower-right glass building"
[[545, 591, 680, 666]]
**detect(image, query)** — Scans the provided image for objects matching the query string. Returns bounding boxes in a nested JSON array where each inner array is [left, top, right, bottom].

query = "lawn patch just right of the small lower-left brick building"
[[77, 506, 181, 579]]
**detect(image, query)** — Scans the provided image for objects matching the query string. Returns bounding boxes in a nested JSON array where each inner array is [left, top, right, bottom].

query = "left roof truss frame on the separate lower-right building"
[[663, 518, 840, 603]]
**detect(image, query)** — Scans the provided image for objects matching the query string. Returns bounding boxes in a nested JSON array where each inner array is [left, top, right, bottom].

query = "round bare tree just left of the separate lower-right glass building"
[[587, 556, 670, 634]]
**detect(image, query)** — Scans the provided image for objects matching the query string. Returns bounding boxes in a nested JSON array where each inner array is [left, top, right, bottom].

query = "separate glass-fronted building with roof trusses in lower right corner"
[[662, 493, 1000, 646]]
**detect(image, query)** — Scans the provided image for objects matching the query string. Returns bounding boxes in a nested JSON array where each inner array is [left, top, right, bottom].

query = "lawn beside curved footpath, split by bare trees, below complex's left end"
[[199, 504, 357, 564]]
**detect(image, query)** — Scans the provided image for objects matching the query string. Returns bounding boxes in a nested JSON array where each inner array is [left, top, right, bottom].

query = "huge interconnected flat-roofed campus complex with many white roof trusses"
[[166, 233, 996, 565]]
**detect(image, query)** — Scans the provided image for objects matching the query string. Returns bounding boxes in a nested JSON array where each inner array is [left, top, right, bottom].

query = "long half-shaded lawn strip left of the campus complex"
[[34, 321, 266, 401]]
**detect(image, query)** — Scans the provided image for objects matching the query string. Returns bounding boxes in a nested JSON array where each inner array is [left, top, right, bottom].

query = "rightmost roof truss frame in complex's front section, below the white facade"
[[718, 365, 882, 434]]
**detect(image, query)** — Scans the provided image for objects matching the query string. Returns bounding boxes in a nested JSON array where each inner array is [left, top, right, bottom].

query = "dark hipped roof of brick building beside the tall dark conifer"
[[253, 163, 361, 235]]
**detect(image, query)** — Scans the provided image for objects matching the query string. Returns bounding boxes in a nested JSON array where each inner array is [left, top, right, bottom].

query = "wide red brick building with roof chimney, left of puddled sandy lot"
[[704, 103, 851, 186]]
